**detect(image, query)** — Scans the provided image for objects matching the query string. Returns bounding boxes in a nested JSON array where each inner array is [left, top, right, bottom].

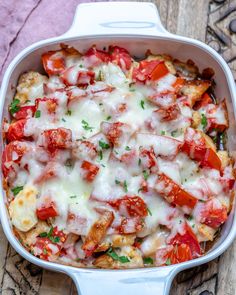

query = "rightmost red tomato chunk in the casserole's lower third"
[[200, 200, 227, 229]]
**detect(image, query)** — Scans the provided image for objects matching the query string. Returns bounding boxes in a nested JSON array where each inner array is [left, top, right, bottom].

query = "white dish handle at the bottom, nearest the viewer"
[[68, 267, 176, 295]]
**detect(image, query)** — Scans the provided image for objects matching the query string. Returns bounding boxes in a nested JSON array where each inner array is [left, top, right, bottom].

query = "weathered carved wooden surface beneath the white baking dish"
[[0, 0, 236, 295]]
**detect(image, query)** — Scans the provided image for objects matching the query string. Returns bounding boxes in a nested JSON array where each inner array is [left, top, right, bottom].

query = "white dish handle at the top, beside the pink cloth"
[[63, 2, 170, 37]]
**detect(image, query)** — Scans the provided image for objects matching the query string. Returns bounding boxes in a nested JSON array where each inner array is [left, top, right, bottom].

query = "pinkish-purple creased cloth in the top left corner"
[[0, 0, 95, 82]]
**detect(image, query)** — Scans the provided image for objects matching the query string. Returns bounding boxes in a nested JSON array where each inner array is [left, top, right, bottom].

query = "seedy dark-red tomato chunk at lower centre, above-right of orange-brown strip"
[[109, 195, 148, 217]]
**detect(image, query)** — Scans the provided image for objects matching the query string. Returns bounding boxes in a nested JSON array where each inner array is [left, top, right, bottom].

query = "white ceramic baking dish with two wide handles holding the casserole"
[[0, 2, 236, 295]]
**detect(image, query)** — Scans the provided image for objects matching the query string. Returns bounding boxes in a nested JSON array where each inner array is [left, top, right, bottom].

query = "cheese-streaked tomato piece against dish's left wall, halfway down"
[[2, 141, 27, 177]]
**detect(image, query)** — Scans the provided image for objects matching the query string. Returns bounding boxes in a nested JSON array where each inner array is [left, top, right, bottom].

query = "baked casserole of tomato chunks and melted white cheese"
[[2, 44, 235, 269]]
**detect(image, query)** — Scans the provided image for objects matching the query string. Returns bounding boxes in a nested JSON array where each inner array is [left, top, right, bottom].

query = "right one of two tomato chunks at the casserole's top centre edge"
[[108, 46, 132, 70]]
